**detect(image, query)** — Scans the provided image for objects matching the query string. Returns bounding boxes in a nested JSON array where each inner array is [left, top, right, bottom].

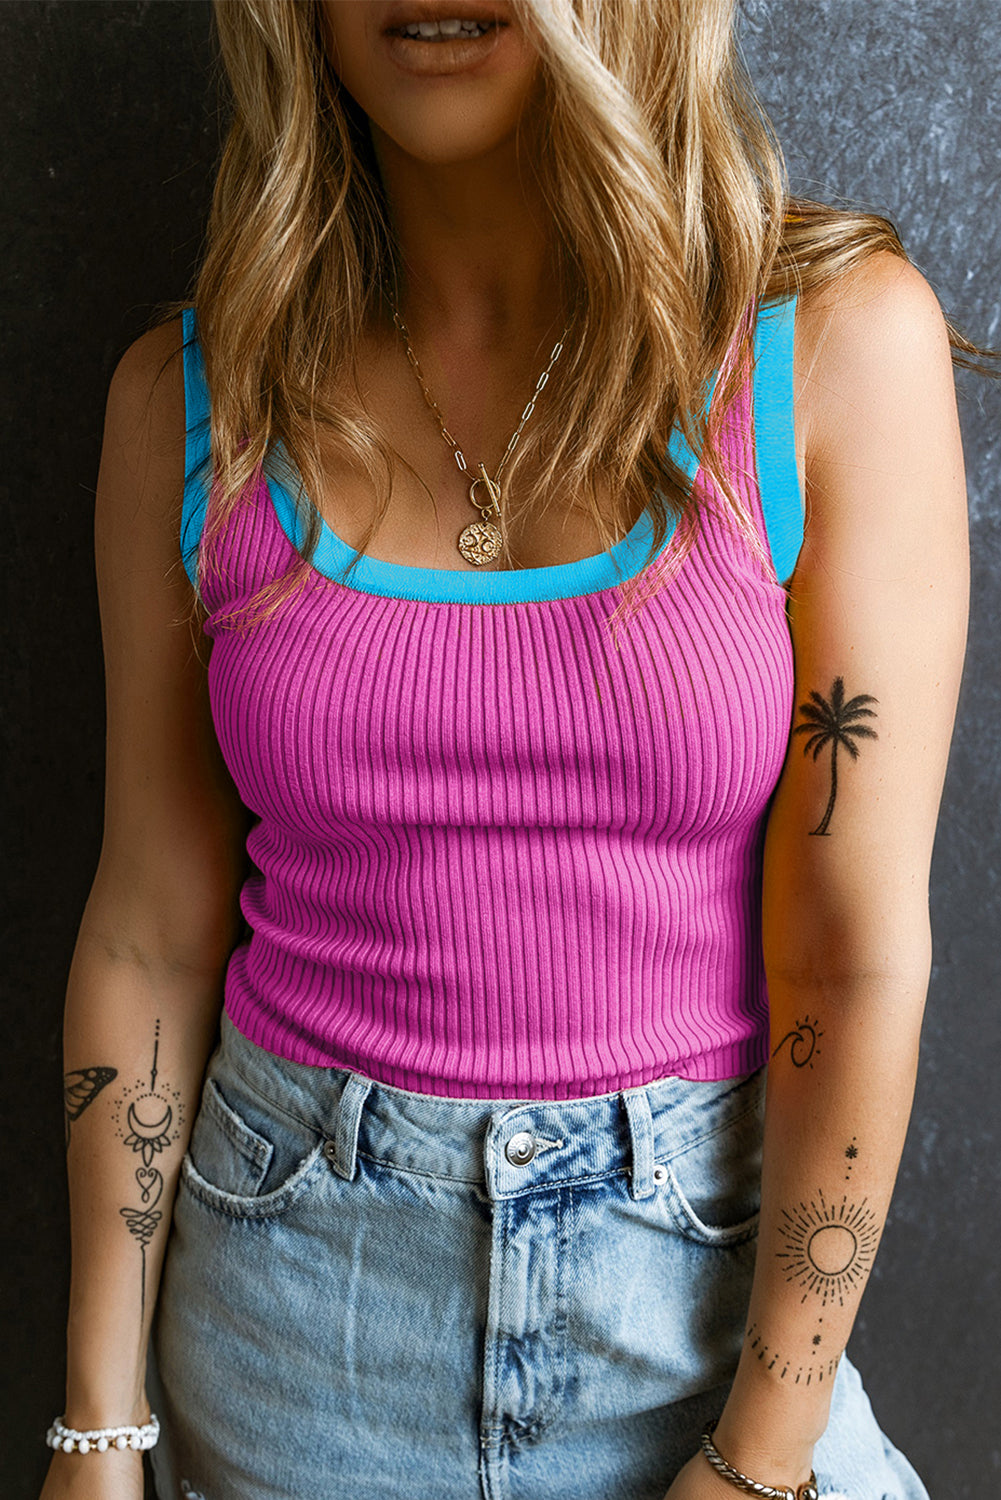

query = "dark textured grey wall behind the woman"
[[0, 0, 1001, 1500]]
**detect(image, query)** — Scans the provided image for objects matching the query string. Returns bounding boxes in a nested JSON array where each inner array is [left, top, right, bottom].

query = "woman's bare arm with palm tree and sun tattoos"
[[671, 254, 968, 1500]]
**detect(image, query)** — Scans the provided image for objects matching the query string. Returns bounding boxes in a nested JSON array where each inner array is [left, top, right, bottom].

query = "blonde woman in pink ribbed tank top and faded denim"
[[44, 0, 969, 1500]]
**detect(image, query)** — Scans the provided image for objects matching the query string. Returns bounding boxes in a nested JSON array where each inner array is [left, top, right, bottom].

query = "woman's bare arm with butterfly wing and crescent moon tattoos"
[[42, 321, 248, 1500]]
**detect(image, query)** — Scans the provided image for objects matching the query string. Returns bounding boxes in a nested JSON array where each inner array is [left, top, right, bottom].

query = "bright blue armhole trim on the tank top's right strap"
[[753, 297, 803, 584]]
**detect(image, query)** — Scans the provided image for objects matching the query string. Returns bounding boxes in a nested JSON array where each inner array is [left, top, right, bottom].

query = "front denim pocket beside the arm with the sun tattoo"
[[663, 1076, 764, 1247]]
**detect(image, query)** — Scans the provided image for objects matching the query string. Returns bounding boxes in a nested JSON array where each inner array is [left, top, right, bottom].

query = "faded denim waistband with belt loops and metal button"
[[218, 1011, 765, 1199]]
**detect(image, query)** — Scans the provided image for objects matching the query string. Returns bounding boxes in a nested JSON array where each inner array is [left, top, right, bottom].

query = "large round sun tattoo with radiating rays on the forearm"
[[777, 1193, 879, 1307]]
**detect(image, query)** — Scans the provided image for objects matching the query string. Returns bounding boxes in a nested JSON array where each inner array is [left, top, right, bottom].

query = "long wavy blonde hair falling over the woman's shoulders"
[[165, 0, 972, 624]]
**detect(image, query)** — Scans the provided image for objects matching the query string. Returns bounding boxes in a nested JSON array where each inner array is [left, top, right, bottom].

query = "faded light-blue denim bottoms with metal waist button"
[[150, 1016, 927, 1500]]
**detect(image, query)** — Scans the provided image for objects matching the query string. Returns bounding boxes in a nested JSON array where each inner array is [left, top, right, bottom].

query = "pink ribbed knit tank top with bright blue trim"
[[182, 302, 803, 1100]]
